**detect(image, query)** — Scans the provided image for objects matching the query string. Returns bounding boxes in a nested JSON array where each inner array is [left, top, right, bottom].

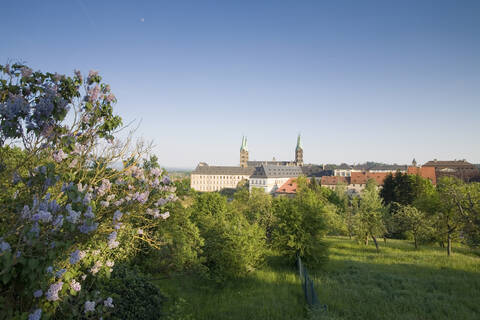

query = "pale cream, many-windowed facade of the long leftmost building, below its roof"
[[190, 174, 249, 191]]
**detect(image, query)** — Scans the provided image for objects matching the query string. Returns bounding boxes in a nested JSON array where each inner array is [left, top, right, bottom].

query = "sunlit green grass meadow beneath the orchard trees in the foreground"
[[157, 237, 480, 320]]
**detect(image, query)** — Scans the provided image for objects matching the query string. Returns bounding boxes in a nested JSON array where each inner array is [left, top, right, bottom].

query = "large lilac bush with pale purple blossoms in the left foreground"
[[0, 64, 177, 319]]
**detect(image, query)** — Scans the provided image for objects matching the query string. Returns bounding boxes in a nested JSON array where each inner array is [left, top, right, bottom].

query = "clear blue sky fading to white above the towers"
[[0, 0, 480, 167]]
